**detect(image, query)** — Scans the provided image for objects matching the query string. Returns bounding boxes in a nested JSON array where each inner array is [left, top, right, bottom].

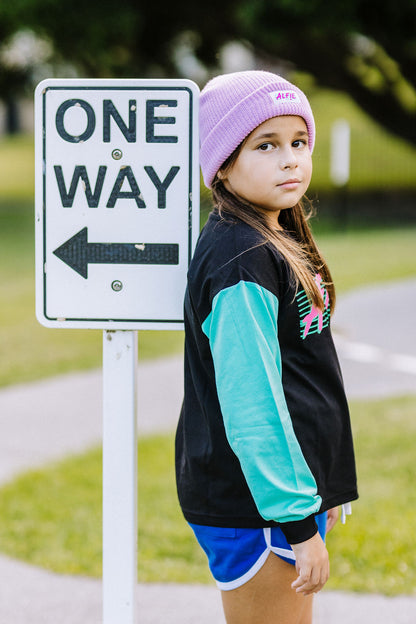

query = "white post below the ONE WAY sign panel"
[[103, 331, 137, 624]]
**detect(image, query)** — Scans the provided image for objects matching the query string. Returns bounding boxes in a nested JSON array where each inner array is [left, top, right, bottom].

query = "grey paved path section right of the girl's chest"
[[334, 279, 416, 400]]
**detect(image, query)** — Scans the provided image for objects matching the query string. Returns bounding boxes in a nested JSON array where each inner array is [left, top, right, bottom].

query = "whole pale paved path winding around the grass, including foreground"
[[0, 280, 416, 624]]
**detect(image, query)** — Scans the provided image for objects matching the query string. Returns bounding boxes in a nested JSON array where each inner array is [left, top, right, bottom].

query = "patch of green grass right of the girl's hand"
[[328, 397, 416, 595]]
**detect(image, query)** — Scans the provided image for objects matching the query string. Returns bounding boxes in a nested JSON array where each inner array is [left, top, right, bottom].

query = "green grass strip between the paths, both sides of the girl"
[[0, 397, 416, 595]]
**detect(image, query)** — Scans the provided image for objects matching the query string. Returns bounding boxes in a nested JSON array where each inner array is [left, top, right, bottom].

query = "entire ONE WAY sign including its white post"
[[35, 79, 199, 624]]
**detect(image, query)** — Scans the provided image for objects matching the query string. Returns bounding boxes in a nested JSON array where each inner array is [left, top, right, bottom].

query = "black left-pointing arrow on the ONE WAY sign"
[[53, 227, 179, 279]]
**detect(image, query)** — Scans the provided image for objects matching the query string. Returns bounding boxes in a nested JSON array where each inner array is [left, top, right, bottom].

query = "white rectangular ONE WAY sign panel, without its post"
[[35, 80, 199, 329]]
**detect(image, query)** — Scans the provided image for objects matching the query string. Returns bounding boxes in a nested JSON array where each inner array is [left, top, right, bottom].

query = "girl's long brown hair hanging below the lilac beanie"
[[212, 168, 335, 313]]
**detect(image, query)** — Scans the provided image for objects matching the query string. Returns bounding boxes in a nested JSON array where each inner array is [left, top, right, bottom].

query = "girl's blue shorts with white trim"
[[190, 512, 327, 591]]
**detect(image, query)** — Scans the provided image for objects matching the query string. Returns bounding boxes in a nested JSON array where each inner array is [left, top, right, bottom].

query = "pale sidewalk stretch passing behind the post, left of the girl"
[[0, 356, 183, 484]]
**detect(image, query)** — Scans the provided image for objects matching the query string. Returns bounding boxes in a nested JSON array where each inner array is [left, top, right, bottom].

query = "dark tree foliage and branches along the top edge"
[[0, 0, 416, 144]]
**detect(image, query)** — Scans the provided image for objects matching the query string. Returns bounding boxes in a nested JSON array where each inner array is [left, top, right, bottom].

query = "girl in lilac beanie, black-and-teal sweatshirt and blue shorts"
[[176, 71, 357, 624]]
